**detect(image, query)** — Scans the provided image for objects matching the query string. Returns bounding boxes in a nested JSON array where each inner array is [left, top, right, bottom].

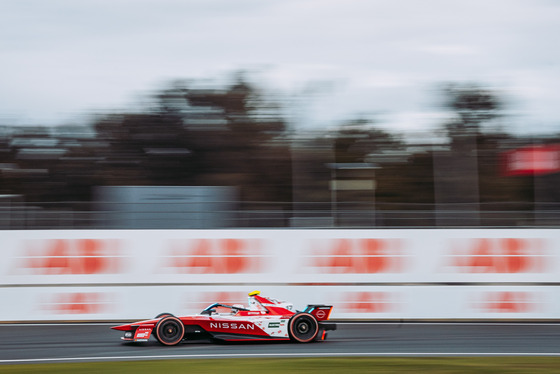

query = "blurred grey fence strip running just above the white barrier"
[[0, 202, 560, 230]]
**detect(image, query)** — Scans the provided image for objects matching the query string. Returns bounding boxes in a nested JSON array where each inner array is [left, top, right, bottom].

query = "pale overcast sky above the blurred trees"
[[0, 0, 560, 132]]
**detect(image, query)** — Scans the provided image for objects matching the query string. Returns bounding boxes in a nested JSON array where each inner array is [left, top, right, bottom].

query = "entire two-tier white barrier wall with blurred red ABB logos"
[[0, 229, 560, 321]]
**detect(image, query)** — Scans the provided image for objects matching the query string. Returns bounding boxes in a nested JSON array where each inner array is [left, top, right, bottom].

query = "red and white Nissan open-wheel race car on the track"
[[112, 291, 336, 345]]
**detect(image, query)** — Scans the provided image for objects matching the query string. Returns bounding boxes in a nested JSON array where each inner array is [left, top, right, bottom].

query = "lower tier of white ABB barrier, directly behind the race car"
[[0, 285, 560, 321]]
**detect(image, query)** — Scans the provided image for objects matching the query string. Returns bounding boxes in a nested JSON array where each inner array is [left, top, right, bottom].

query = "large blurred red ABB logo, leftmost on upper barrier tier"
[[20, 239, 121, 275]]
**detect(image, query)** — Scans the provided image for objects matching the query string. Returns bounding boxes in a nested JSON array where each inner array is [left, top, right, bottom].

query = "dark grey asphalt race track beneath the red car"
[[0, 323, 560, 364]]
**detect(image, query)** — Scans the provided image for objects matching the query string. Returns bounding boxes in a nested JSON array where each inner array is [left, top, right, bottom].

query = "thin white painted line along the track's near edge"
[[0, 352, 560, 364]]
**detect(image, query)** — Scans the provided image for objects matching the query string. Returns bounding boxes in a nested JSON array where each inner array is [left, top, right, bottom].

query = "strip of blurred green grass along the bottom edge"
[[0, 357, 560, 374]]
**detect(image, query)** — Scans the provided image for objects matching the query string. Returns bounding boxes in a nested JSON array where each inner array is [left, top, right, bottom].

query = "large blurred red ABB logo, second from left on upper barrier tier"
[[166, 239, 265, 274]]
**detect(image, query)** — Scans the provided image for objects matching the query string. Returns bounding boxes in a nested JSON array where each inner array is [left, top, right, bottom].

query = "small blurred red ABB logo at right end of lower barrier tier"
[[475, 291, 540, 313]]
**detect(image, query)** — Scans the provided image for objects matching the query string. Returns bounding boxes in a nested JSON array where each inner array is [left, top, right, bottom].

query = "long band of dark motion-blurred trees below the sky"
[[0, 76, 560, 226]]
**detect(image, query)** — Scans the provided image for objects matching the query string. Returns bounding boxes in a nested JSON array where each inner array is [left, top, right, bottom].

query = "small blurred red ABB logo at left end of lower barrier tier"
[[41, 292, 114, 314]]
